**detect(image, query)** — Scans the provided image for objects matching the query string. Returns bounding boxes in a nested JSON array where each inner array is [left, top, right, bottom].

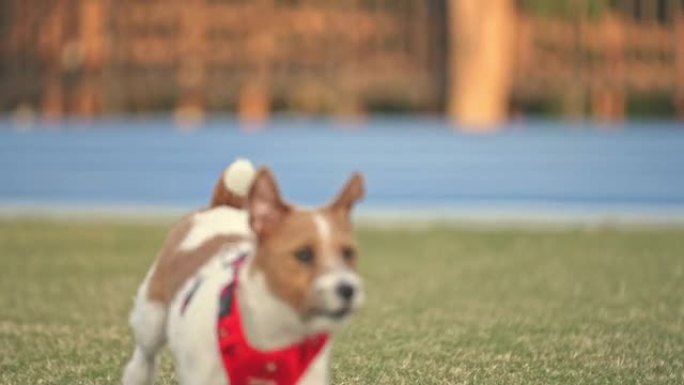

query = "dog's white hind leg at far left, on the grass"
[[122, 283, 167, 385]]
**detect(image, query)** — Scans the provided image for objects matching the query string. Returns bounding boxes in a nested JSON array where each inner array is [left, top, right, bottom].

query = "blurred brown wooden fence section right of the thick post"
[[513, 12, 684, 119]]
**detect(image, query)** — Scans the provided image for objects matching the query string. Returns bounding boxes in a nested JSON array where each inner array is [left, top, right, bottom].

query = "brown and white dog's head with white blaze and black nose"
[[246, 168, 365, 331]]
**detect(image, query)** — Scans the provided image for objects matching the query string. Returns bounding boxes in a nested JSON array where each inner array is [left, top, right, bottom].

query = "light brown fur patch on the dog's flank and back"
[[147, 215, 248, 304]]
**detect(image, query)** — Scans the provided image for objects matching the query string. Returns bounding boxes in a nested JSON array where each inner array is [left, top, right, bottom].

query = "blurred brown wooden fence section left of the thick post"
[[0, 0, 439, 118]]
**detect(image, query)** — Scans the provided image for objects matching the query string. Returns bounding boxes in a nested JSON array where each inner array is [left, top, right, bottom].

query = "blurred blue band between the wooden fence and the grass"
[[0, 118, 684, 219]]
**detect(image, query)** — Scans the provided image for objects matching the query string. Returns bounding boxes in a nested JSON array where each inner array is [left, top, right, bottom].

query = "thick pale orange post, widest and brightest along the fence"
[[447, 0, 516, 131]]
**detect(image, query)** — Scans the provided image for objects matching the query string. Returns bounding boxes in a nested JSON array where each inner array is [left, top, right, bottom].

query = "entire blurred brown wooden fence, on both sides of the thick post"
[[0, 0, 684, 119]]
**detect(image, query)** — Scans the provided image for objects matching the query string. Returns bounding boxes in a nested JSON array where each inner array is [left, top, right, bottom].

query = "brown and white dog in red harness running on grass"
[[123, 160, 365, 385]]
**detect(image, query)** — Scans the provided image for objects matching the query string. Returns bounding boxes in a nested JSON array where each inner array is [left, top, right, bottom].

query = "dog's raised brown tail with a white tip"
[[210, 158, 256, 209]]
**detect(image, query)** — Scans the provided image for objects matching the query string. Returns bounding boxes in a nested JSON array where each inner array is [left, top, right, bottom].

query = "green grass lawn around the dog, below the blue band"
[[0, 219, 684, 385]]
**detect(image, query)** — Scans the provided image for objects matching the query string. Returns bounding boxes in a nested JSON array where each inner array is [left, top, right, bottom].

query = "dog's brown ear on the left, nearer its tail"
[[247, 167, 290, 237]]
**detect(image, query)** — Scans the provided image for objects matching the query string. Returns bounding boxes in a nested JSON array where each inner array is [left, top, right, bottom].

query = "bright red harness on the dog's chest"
[[217, 257, 328, 385]]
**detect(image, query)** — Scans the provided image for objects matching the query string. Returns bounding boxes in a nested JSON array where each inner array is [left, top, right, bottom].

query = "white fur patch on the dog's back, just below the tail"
[[180, 206, 251, 251]]
